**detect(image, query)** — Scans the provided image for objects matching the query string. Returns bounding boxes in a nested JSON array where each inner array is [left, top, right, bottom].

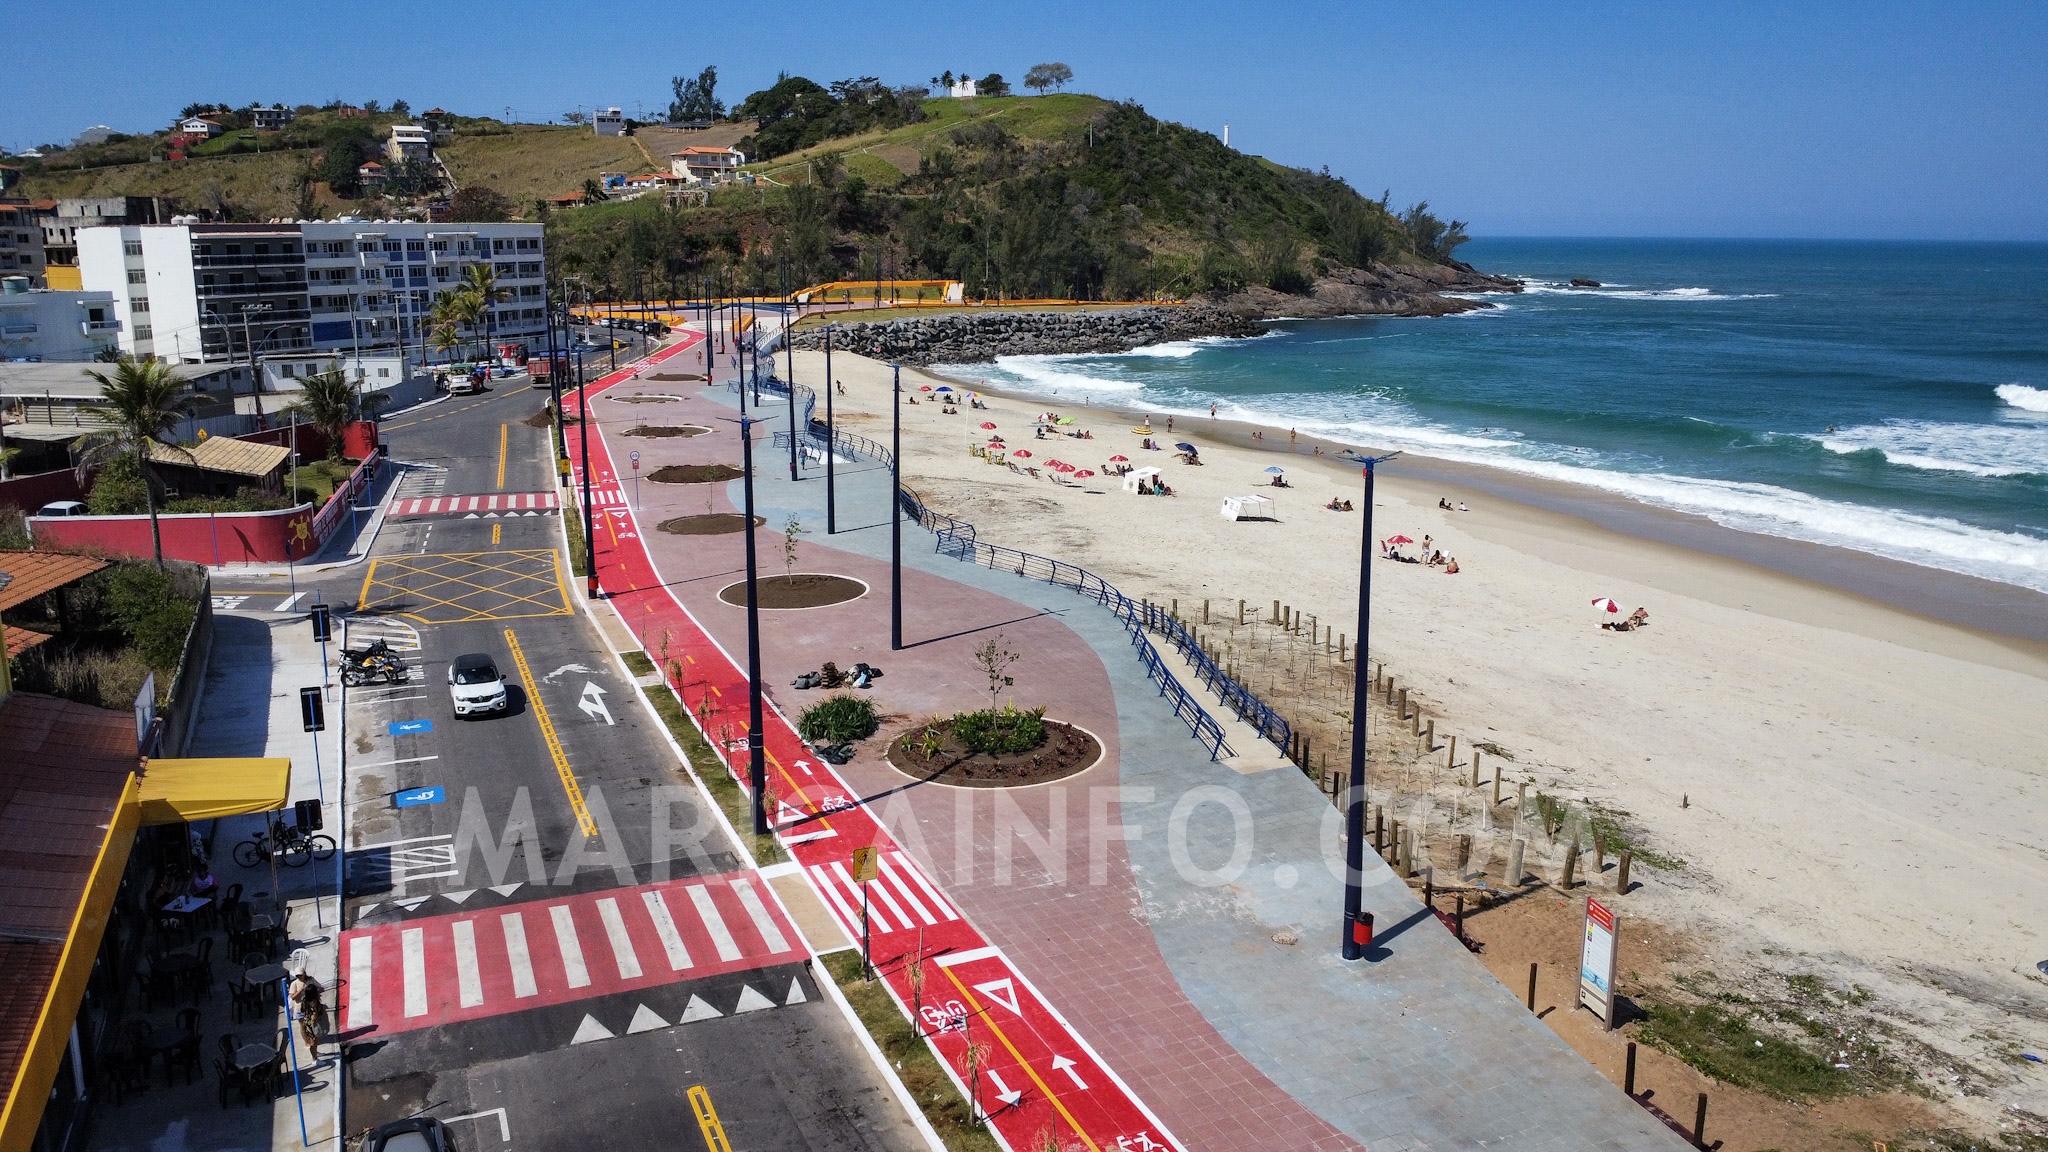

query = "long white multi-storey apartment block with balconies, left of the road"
[[78, 219, 545, 373]]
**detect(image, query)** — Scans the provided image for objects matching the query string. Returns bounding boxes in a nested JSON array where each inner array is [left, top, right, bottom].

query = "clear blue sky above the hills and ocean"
[[16, 0, 2048, 240]]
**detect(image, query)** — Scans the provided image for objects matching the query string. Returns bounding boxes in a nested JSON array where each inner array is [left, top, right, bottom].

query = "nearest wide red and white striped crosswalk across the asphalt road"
[[342, 873, 805, 1035]]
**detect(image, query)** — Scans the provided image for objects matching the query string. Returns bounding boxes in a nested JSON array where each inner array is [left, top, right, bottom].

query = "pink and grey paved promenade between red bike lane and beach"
[[598, 377, 1683, 1152]]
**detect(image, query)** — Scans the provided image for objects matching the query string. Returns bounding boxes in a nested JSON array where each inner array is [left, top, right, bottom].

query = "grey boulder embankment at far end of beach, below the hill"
[[793, 303, 1266, 365]]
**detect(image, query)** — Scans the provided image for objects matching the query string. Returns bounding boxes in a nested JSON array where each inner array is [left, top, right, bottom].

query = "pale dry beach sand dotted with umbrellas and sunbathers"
[[795, 344, 2048, 1111]]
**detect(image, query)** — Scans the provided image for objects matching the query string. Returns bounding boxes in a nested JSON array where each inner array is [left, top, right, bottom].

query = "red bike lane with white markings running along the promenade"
[[563, 334, 1182, 1152]]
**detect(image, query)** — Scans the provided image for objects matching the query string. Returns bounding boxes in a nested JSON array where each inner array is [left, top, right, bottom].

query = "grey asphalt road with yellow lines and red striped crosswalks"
[[215, 373, 924, 1152]]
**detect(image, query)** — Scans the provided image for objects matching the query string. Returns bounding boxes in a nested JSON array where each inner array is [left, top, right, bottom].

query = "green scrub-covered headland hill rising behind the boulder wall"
[[551, 80, 1462, 299]]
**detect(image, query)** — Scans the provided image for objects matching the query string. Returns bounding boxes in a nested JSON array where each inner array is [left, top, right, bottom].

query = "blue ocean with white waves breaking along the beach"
[[940, 240, 2048, 592]]
